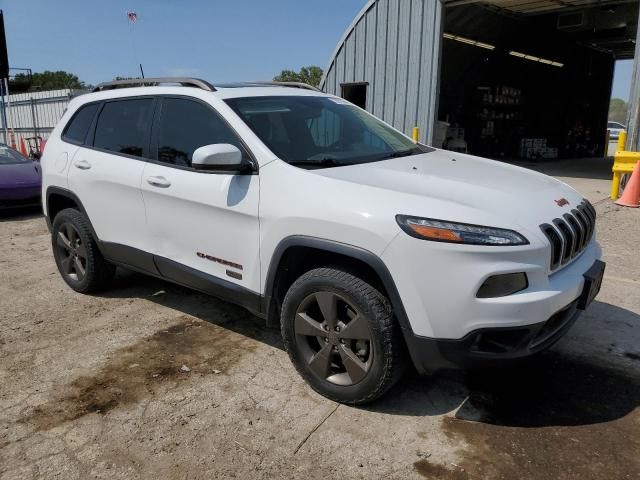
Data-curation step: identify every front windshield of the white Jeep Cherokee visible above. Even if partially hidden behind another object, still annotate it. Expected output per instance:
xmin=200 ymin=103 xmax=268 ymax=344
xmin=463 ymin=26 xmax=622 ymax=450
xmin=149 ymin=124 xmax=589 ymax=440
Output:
xmin=226 ymin=96 xmax=431 ymax=168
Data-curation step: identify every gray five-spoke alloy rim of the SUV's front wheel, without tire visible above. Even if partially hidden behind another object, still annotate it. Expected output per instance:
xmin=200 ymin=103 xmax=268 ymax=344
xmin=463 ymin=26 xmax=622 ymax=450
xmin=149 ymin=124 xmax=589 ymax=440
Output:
xmin=294 ymin=291 xmax=375 ymax=386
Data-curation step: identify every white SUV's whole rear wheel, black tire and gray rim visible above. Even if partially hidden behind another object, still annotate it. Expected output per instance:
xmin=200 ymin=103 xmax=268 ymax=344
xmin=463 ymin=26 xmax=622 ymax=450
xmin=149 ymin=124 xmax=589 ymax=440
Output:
xmin=51 ymin=208 xmax=116 ymax=293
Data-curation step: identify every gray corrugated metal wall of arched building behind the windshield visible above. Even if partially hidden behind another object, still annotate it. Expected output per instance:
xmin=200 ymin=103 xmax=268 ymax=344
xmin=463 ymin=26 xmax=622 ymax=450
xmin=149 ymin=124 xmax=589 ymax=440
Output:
xmin=320 ymin=0 xmax=442 ymax=143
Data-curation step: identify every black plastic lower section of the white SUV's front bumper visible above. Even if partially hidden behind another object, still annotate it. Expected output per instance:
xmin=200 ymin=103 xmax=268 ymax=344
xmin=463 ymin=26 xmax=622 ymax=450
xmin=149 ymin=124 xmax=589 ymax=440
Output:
xmin=407 ymin=301 xmax=581 ymax=373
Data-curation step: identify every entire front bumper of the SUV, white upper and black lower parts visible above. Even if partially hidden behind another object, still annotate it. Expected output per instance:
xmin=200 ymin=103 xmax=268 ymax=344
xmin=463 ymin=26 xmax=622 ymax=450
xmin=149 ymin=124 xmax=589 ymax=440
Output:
xmin=382 ymin=234 xmax=602 ymax=372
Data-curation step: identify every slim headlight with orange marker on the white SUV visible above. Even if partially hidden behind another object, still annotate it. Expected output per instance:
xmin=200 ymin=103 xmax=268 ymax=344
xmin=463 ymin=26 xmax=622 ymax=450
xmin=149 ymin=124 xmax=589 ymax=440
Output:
xmin=396 ymin=215 xmax=529 ymax=246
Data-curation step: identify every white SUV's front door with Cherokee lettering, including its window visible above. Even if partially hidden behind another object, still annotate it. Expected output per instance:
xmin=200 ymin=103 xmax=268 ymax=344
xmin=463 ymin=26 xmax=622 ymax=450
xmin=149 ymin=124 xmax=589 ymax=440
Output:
xmin=141 ymin=97 xmax=260 ymax=292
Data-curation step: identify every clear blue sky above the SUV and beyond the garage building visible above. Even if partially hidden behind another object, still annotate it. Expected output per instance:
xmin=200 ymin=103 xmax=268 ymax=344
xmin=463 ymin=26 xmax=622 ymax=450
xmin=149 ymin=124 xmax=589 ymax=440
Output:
xmin=0 ymin=0 xmax=632 ymax=100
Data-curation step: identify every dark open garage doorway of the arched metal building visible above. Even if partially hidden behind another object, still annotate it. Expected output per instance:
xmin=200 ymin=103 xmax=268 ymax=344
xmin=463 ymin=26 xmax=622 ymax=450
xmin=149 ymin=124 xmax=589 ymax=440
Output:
xmin=437 ymin=0 xmax=638 ymax=159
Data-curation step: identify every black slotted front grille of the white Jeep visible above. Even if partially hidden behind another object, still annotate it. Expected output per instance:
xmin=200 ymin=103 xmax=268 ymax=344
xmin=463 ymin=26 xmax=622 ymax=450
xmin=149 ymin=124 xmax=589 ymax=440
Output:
xmin=540 ymin=200 xmax=596 ymax=271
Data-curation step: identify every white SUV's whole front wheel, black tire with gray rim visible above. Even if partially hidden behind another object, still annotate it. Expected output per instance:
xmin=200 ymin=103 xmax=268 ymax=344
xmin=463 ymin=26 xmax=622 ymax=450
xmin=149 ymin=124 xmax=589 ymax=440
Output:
xmin=281 ymin=268 xmax=406 ymax=405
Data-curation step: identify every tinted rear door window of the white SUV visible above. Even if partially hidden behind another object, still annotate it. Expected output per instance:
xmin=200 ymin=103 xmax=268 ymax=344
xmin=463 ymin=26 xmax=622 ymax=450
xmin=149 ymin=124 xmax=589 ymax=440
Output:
xmin=93 ymin=98 xmax=153 ymax=157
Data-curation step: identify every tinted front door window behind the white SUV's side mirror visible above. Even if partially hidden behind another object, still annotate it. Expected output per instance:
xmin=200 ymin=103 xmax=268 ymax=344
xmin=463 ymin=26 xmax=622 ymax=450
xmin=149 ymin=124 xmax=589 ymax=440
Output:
xmin=158 ymin=98 xmax=248 ymax=167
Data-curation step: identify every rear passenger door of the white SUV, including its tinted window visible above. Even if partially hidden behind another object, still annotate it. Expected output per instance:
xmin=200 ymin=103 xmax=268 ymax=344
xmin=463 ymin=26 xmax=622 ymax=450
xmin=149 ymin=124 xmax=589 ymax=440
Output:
xmin=68 ymin=97 xmax=156 ymax=253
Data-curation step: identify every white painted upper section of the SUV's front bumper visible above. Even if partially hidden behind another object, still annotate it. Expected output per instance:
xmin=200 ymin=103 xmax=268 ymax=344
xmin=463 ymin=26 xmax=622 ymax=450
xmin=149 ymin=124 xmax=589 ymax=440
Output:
xmin=382 ymin=234 xmax=602 ymax=340
